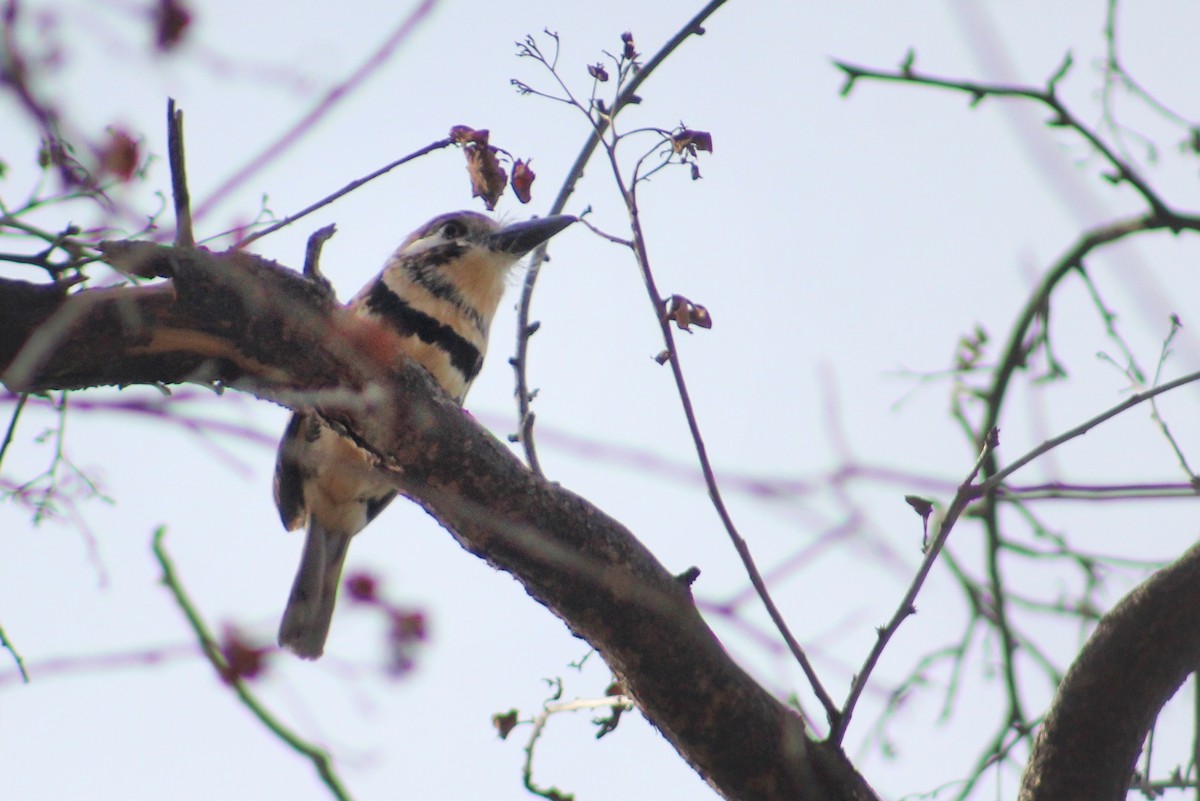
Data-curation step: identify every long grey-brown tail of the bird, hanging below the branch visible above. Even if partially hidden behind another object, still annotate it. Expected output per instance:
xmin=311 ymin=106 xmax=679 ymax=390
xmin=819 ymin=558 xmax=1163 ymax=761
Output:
xmin=280 ymin=517 xmax=350 ymax=660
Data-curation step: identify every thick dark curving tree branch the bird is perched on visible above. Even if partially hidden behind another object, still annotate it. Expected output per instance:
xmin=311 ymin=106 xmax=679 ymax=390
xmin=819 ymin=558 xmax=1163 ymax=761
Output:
xmin=0 ymin=242 xmax=875 ymax=801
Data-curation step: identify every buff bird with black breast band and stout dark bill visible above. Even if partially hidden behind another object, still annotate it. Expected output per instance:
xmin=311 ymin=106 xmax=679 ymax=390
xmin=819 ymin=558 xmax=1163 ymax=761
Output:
xmin=274 ymin=211 xmax=576 ymax=660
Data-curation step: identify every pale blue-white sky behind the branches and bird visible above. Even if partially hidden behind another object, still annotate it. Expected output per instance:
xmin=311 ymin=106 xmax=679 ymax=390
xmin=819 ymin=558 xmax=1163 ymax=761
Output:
xmin=0 ymin=0 xmax=1200 ymax=801
